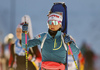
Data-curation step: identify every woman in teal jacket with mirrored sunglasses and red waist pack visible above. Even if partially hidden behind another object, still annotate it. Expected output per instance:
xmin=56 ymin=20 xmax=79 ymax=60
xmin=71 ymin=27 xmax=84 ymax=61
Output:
xmin=22 ymin=12 xmax=79 ymax=70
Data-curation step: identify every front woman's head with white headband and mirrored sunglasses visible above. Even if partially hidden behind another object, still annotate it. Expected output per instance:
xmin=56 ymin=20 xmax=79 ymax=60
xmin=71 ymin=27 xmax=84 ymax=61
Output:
xmin=48 ymin=12 xmax=62 ymax=31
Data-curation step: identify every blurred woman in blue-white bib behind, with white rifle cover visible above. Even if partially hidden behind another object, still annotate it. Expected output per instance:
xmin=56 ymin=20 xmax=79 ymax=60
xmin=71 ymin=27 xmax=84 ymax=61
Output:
xmin=9 ymin=15 xmax=42 ymax=70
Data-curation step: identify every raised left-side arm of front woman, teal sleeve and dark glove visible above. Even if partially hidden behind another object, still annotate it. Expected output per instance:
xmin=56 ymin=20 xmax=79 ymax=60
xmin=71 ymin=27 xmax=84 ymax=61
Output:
xmin=21 ymin=24 xmax=44 ymax=48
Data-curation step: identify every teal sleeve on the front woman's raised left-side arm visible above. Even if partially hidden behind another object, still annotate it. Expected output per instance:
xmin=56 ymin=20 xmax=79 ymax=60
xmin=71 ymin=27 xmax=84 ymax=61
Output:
xmin=22 ymin=33 xmax=44 ymax=48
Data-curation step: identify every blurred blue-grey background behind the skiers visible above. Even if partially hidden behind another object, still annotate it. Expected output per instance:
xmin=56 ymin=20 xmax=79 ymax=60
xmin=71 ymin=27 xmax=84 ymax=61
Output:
xmin=0 ymin=0 xmax=100 ymax=70
